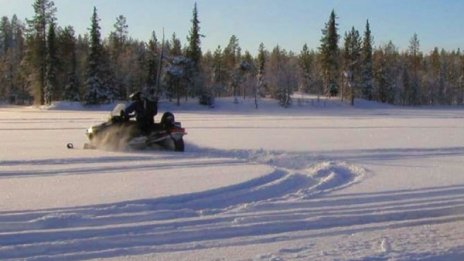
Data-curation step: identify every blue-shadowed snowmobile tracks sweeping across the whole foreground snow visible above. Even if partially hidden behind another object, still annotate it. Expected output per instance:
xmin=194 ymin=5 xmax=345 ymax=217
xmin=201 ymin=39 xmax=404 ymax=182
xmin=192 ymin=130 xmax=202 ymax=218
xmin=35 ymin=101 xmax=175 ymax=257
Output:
xmin=0 ymin=152 xmax=464 ymax=260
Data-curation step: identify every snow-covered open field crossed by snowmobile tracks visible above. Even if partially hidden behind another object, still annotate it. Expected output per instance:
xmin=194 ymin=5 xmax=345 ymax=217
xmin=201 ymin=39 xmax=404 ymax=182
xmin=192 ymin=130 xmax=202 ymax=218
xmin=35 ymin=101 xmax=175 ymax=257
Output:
xmin=0 ymin=96 xmax=464 ymax=260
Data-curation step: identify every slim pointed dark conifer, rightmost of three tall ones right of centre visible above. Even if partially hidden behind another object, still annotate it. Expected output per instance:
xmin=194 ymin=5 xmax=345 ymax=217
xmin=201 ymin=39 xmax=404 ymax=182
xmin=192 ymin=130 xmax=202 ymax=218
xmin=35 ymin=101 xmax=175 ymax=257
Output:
xmin=362 ymin=20 xmax=374 ymax=100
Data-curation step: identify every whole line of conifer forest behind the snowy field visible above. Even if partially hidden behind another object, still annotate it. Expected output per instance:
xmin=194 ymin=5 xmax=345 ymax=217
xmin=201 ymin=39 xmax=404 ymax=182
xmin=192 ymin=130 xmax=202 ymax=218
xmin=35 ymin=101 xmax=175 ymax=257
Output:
xmin=0 ymin=0 xmax=464 ymax=108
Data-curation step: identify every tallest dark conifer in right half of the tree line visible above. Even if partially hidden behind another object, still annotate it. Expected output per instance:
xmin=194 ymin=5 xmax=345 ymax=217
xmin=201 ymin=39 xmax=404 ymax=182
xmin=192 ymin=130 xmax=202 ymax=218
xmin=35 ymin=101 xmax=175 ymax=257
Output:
xmin=319 ymin=10 xmax=340 ymax=96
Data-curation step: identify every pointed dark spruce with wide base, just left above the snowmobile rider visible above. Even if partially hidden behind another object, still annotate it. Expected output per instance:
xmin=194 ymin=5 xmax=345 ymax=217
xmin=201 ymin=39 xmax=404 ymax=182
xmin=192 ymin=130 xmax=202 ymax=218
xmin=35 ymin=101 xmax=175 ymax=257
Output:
xmin=84 ymin=7 xmax=111 ymax=104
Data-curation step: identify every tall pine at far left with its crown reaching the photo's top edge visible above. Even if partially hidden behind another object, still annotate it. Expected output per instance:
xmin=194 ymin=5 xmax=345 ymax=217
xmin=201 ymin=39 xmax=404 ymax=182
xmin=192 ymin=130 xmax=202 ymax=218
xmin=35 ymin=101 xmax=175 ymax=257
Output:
xmin=27 ymin=0 xmax=56 ymax=105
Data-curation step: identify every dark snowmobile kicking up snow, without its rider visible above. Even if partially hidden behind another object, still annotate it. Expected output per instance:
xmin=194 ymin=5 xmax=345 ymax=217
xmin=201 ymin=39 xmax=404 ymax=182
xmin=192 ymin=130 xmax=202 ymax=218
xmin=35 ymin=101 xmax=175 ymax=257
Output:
xmin=84 ymin=104 xmax=187 ymax=151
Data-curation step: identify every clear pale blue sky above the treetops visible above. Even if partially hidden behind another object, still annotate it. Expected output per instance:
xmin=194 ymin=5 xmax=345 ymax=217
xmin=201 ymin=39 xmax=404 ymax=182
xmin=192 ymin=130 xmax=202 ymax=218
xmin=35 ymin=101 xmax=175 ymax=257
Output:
xmin=0 ymin=0 xmax=464 ymax=54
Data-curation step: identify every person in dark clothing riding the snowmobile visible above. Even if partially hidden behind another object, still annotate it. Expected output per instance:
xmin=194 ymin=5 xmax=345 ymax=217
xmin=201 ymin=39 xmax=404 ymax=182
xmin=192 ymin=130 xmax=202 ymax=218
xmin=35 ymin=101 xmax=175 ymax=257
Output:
xmin=124 ymin=90 xmax=158 ymax=134
